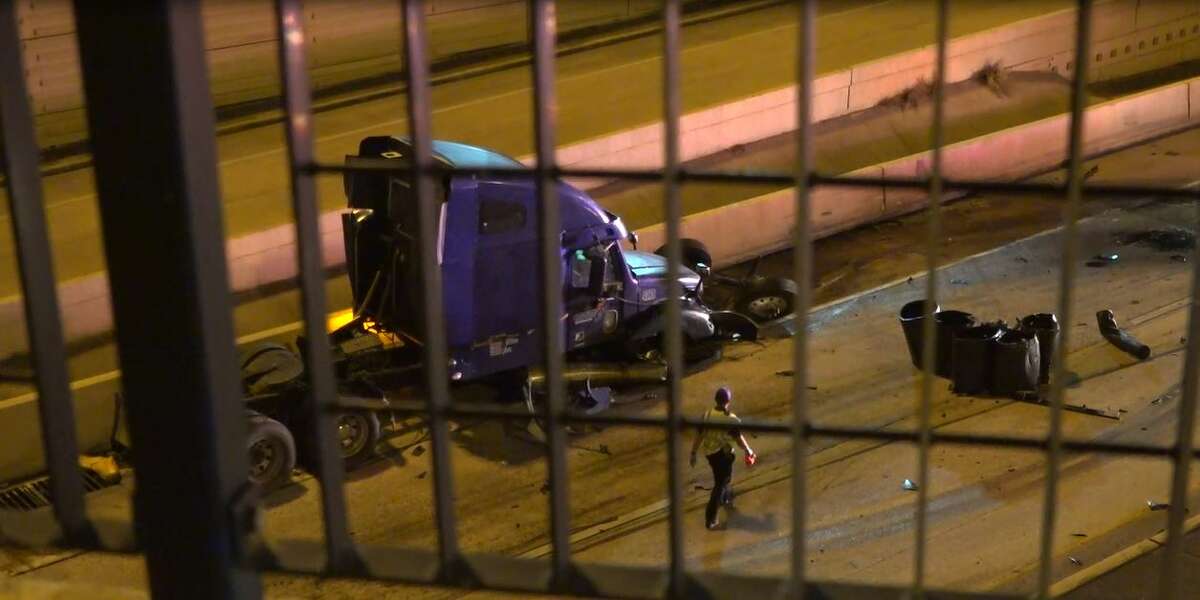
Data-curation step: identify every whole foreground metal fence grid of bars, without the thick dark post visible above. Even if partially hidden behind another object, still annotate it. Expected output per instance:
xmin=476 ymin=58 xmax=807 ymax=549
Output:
xmin=0 ymin=0 xmax=1200 ymax=598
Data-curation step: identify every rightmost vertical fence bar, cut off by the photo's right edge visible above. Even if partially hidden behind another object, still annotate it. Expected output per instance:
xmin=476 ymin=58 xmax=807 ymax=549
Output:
xmin=1158 ymin=204 xmax=1200 ymax=600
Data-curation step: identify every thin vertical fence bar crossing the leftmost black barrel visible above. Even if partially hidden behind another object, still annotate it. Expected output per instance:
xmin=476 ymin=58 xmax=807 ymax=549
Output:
xmin=912 ymin=0 xmax=949 ymax=598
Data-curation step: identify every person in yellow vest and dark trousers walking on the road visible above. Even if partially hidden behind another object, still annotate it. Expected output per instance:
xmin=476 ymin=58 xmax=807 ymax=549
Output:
xmin=689 ymin=386 xmax=756 ymax=529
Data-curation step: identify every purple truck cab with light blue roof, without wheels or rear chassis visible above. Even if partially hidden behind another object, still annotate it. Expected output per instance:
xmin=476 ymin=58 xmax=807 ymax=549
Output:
xmin=343 ymin=137 xmax=716 ymax=380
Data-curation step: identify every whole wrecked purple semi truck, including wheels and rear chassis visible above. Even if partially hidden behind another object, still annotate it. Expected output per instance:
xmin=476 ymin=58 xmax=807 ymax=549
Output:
xmin=242 ymin=137 xmax=794 ymax=486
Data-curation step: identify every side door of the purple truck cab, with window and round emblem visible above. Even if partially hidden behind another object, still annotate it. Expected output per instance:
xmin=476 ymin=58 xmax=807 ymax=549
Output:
xmin=563 ymin=242 xmax=625 ymax=349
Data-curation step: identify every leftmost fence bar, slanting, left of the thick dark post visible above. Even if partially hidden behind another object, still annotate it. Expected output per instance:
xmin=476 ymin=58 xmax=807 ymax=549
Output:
xmin=0 ymin=1 xmax=95 ymax=545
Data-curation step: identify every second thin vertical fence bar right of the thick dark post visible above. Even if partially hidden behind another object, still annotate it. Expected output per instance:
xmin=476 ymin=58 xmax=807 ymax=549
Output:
xmin=403 ymin=0 xmax=467 ymax=583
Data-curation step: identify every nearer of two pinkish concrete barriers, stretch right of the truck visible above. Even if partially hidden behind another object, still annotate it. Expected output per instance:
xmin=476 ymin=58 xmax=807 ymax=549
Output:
xmin=638 ymin=78 xmax=1200 ymax=266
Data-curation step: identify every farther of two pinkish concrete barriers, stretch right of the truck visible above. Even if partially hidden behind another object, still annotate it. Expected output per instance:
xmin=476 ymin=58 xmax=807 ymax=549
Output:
xmin=549 ymin=0 xmax=1200 ymax=174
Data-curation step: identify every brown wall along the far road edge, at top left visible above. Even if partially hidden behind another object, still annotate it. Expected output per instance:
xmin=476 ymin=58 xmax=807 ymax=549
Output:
xmin=17 ymin=0 xmax=660 ymax=146
